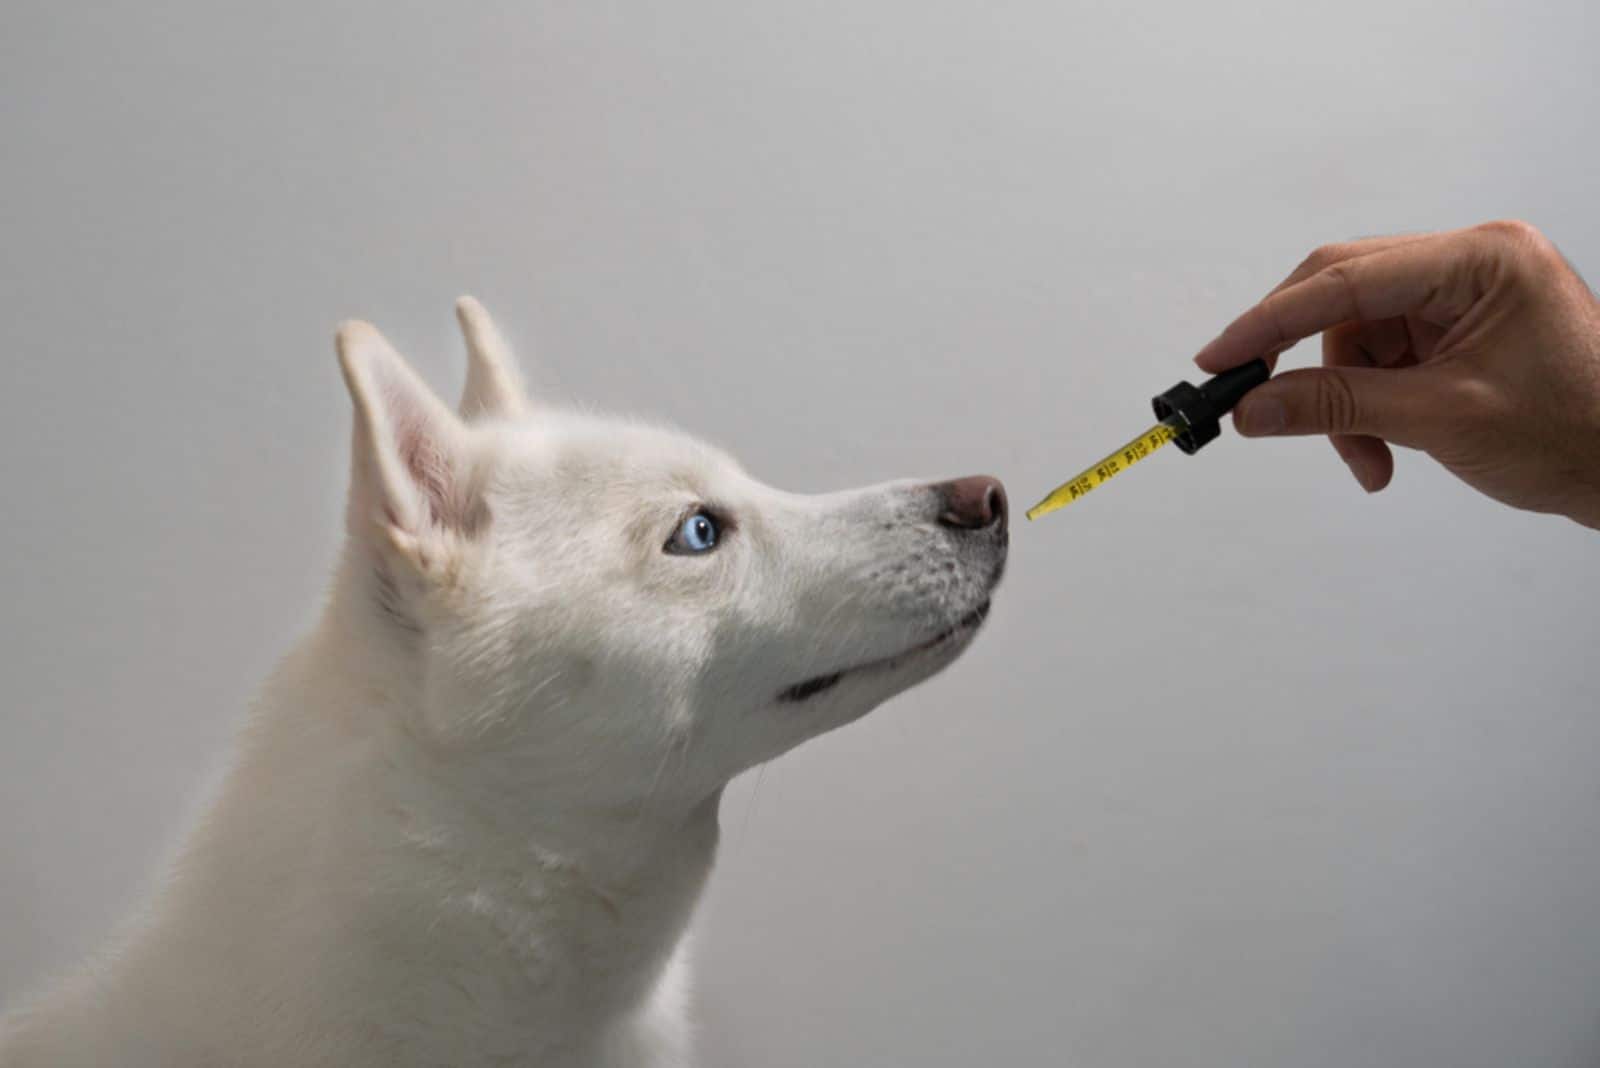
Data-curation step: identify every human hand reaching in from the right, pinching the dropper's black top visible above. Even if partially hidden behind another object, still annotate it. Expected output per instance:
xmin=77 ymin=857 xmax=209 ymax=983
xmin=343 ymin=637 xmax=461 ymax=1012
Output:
xmin=1195 ymin=222 xmax=1600 ymax=528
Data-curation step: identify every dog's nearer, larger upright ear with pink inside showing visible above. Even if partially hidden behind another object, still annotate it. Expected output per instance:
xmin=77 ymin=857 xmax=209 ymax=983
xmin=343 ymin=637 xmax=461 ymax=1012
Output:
xmin=338 ymin=323 xmax=483 ymax=572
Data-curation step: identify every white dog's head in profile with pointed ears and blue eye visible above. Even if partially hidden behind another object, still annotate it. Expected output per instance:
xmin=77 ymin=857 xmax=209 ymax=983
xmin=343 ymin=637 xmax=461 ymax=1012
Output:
xmin=338 ymin=299 xmax=1006 ymax=806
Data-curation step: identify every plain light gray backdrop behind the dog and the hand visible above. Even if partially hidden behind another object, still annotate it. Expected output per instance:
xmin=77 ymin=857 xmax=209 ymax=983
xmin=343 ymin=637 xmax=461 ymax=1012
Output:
xmin=0 ymin=0 xmax=1600 ymax=1068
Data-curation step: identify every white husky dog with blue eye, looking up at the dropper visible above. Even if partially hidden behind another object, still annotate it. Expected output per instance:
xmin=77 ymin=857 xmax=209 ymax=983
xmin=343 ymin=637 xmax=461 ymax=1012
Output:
xmin=0 ymin=297 xmax=1006 ymax=1068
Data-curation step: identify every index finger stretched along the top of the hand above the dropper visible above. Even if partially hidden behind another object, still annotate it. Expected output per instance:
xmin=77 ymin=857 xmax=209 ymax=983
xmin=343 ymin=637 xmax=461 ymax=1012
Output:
xmin=1195 ymin=230 xmax=1482 ymax=374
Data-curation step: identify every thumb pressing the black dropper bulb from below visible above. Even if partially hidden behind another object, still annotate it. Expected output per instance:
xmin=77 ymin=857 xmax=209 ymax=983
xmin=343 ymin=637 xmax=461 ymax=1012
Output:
xmin=1234 ymin=368 xmax=1438 ymax=448
